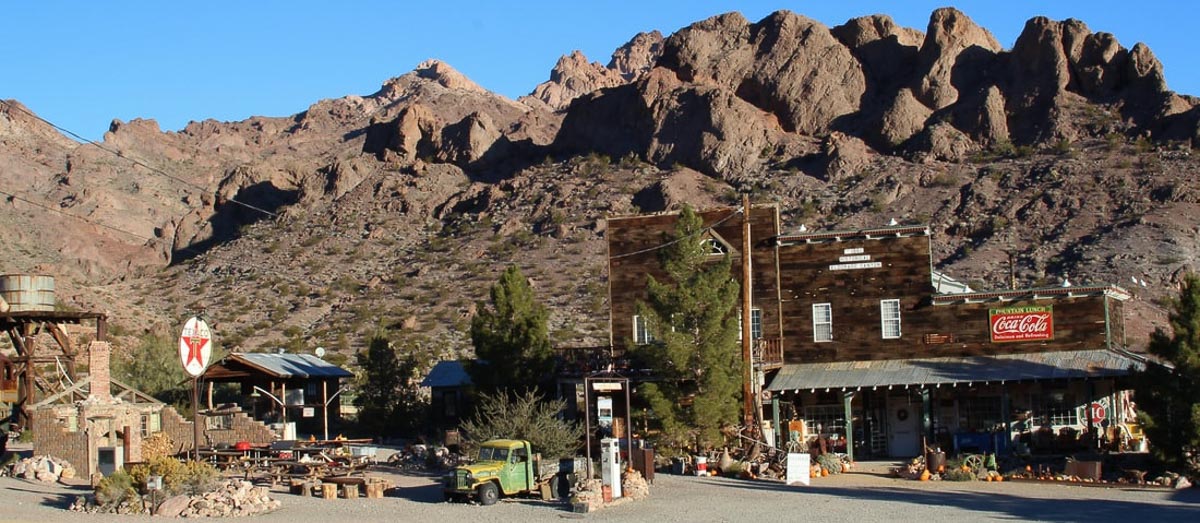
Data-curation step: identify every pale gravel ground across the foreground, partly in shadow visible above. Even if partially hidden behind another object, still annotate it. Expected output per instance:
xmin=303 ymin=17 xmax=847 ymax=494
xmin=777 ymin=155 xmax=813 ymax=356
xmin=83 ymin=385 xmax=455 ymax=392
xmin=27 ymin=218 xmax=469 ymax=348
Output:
xmin=0 ymin=465 xmax=1200 ymax=523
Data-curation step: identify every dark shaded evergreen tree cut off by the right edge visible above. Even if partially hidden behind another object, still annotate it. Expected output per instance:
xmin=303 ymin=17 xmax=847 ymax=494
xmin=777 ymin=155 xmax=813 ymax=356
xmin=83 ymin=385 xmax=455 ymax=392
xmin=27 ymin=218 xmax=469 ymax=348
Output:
xmin=1136 ymin=275 xmax=1200 ymax=471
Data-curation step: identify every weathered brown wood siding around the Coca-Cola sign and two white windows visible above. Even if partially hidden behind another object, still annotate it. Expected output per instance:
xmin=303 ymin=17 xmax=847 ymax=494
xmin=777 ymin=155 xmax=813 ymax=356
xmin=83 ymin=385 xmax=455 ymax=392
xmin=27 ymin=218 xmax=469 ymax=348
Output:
xmin=779 ymin=235 xmax=1123 ymax=362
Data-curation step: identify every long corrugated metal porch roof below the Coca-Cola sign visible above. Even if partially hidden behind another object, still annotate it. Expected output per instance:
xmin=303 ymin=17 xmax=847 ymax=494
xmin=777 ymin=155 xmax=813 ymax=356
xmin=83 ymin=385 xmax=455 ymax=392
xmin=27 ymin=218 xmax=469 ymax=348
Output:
xmin=767 ymin=349 xmax=1145 ymax=391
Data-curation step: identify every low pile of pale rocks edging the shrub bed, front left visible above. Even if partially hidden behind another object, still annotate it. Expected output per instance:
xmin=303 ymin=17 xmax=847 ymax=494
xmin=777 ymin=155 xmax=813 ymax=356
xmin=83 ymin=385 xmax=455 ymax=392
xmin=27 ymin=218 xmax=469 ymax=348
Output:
xmin=71 ymin=480 xmax=281 ymax=517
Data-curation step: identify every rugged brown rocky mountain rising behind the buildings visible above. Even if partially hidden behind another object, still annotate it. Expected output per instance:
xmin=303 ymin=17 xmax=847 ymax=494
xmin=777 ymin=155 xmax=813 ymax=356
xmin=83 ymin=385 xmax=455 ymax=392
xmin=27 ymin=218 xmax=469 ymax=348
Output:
xmin=0 ymin=8 xmax=1200 ymax=364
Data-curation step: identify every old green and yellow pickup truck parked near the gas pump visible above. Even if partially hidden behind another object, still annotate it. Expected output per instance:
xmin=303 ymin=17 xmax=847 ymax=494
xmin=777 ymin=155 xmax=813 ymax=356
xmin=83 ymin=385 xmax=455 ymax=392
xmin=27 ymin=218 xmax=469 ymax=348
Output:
xmin=442 ymin=439 xmax=558 ymax=505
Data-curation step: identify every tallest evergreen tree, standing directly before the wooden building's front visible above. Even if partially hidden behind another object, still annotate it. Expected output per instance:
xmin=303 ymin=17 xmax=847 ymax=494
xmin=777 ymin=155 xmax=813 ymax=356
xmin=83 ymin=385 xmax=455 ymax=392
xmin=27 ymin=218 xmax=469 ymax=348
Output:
xmin=630 ymin=206 xmax=743 ymax=447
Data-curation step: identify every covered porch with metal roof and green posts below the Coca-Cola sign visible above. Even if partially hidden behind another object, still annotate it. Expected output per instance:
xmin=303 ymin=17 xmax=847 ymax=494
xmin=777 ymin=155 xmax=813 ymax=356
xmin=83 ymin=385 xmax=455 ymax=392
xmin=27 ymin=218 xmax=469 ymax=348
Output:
xmin=764 ymin=349 xmax=1145 ymax=458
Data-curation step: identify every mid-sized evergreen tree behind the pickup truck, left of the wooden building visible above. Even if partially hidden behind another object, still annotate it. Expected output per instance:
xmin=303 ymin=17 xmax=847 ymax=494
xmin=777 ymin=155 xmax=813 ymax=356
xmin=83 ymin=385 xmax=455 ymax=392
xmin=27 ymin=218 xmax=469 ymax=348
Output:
xmin=468 ymin=266 xmax=554 ymax=392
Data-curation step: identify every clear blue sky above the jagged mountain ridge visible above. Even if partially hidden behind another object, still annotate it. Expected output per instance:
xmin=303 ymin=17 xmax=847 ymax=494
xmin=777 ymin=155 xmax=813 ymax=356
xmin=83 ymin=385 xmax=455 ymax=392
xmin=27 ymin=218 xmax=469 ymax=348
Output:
xmin=7 ymin=0 xmax=1200 ymax=139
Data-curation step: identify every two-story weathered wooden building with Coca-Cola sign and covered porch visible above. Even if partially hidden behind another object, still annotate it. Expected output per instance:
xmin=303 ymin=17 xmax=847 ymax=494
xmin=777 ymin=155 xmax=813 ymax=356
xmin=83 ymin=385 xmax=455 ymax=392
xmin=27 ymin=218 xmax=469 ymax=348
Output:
xmin=608 ymin=205 xmax=1144 ymax=456
